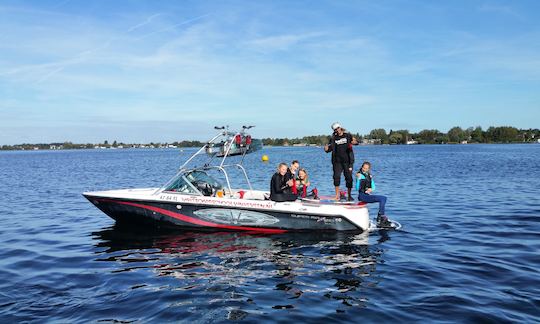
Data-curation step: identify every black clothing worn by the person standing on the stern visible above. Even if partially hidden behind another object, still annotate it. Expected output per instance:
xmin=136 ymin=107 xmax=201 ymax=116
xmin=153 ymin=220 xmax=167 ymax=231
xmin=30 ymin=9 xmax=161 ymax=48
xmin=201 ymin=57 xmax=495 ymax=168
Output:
xmin=327 ymin=133 xmax=354 ymax=188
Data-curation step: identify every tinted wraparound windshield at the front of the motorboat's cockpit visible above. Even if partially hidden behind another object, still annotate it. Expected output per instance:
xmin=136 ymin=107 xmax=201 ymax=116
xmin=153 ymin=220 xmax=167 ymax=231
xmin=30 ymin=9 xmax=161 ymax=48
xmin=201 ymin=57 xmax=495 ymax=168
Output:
xmin=165 ymin=170 xmax=223 ymax=196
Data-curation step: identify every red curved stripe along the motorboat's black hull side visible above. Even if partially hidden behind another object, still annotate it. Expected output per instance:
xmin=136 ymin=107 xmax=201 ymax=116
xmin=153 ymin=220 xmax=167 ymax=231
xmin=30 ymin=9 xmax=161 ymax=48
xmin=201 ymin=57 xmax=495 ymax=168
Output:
xmin=97 ymin=199 xmax=287 ymax=233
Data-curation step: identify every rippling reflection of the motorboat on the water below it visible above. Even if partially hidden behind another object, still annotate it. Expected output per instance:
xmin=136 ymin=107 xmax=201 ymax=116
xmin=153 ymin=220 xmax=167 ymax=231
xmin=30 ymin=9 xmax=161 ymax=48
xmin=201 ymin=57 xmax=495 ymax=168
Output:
xmin=90 ymin=224 xmax=390 ymax=319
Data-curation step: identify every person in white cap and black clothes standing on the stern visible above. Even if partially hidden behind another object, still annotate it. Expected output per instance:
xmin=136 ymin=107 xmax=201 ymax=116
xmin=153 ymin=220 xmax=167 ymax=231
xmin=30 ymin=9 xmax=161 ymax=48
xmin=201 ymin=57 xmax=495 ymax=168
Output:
xmin=324 ymin=122 xmax=358 ymax=201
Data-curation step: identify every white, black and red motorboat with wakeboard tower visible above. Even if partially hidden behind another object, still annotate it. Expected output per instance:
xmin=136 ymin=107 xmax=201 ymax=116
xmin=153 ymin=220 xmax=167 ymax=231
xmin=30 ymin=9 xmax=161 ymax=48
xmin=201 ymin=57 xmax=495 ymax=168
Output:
xmin=83 ymin=126 xmax=370 ymax=233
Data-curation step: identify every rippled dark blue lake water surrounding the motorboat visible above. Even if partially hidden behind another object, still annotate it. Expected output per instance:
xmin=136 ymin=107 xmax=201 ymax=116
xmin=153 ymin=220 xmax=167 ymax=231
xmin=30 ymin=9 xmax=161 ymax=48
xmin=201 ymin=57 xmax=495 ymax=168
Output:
xmin=0 ymin=145 xmax=540 ymax=323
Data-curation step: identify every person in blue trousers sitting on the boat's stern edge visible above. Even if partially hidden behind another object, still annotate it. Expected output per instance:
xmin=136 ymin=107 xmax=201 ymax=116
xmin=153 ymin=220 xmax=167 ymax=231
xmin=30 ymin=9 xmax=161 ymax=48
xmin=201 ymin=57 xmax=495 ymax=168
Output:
xmin=356 ymin=161 xmax=392 ymax=227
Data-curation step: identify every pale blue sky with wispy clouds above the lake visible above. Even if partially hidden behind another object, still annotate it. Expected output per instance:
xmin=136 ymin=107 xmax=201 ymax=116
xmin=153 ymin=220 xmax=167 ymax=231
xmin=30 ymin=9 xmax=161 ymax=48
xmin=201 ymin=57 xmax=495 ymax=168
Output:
xmin=0 ymin=0 xmax=540 ymax=144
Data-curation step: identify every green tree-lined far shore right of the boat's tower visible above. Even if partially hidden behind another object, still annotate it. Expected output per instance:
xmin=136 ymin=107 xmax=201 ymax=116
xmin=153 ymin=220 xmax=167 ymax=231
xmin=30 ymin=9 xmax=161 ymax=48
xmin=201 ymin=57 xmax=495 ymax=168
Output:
xmin=263 ymin=126 xmax=540 ymax=146
